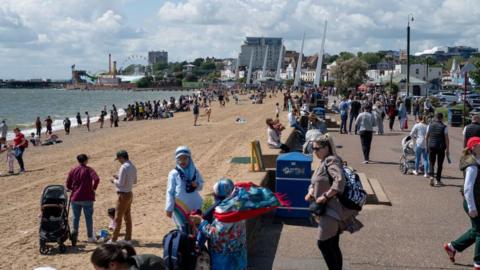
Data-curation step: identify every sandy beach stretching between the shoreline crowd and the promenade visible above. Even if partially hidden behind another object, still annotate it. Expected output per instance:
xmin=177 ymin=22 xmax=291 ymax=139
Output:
xmin=0 ymin=95 xmax=280 ymax=269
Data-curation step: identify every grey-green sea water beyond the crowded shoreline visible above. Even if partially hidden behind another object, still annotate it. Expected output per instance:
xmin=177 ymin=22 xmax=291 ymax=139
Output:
xmin=0 ymin=88 xmax=191 ymax=140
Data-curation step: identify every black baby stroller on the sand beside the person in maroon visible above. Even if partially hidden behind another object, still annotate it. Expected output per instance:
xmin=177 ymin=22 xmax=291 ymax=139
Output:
xmin=39 ymin=185 xmax=76 ymax=255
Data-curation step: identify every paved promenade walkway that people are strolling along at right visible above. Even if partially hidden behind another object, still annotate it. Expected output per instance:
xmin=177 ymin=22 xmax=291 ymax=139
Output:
xmin=251 ymin=116 xmax=473 ymax=269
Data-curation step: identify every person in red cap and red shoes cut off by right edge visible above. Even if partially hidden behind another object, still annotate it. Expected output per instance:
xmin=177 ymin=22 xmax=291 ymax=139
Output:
xmin=443 ymin=136 xmax=480 ymax=270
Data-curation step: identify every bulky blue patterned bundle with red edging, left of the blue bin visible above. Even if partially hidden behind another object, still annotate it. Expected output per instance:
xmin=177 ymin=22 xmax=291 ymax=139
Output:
xmin=213 ymin=182 xmax=290 ymax=223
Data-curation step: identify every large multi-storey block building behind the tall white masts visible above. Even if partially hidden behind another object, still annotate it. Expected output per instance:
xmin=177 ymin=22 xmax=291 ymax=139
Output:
xmin=239 ymin=37 xmax=285 ymax=70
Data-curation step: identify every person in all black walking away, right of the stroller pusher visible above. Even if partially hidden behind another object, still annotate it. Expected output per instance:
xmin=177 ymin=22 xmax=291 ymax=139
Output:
xmin=427 ymin=113 xmax=450 ymax=187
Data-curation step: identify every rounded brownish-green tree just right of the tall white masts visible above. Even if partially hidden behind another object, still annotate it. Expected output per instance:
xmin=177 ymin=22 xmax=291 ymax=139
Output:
xmin=332 ymin=57 xmax=368 ymax=94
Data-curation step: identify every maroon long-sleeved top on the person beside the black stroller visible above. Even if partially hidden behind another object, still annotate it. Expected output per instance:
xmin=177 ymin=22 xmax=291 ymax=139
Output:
xmin=66 ymin=165 xmax=100 ymax=201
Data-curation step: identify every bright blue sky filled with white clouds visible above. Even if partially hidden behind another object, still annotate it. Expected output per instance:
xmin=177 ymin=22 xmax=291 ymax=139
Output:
xmin=0 ymin=0 xmax=480 ymax=79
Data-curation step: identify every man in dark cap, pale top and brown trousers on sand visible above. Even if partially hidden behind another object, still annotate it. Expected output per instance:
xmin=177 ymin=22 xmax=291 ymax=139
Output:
xmin=110 ymin=150 xmax=137 ymax=242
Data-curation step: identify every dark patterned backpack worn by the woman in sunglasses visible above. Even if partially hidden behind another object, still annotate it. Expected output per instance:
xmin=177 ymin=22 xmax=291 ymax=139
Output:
xmin=325 ymin=164 xmax=367 ymax=211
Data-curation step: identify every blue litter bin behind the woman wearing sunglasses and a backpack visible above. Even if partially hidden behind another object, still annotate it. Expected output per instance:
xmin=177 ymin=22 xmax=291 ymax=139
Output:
xmin=275 ymin=152 xmax=312 ymax=218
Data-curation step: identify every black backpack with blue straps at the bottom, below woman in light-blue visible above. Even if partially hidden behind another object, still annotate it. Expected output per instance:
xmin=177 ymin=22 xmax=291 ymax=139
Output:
xmin=163 ymin=230 xmax=197 ymax=270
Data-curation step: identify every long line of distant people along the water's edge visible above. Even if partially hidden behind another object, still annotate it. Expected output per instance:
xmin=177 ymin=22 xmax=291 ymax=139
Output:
xmin=0 ymin=89 xmax=238 ymax=175
